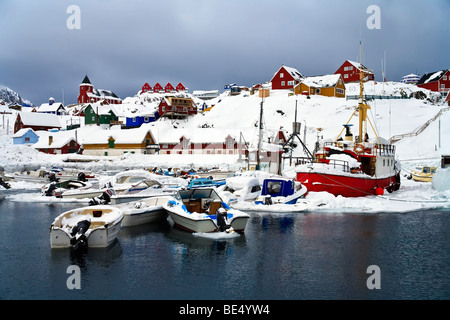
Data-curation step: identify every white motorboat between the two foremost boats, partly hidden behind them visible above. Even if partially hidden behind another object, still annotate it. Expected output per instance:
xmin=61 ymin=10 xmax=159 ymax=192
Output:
xmin=116 ymin=196 xmax=172 ymax=227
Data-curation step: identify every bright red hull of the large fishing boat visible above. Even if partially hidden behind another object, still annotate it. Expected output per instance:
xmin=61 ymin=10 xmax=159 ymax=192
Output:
xmin=297 ymin=171 xmax=400 ymax=197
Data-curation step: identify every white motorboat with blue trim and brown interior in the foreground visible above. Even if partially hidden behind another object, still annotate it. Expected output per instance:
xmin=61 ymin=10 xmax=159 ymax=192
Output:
xmin=164 ymin=188 xmax=249 ymax=232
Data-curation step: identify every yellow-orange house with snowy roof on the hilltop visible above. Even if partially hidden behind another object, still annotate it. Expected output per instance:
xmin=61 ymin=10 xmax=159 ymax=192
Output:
xmin=294 ymin=74 xmax=345 ymax=98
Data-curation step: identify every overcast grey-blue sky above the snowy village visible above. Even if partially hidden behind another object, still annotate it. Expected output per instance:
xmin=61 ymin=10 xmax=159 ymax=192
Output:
xmin=0 ymin=0 xmax=450 ymax=105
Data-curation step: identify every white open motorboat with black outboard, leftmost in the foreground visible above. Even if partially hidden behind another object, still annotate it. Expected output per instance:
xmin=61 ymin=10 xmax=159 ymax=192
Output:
xmin=50 ymin=205 xmax=124 ymax=248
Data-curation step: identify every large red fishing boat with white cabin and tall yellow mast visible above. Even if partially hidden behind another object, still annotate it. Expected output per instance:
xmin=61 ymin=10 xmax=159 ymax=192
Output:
xmin=295 ymin=47 xmax=400 ymax=197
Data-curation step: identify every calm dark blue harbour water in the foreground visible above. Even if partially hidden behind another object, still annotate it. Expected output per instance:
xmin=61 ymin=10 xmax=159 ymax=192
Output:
xmin=0 ymin=194 xmax=450 ymax=300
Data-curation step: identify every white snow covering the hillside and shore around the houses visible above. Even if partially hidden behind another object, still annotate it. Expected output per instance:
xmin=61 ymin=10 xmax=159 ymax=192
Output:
xmin=0 ymin=83 xmax=450 ymax=212
